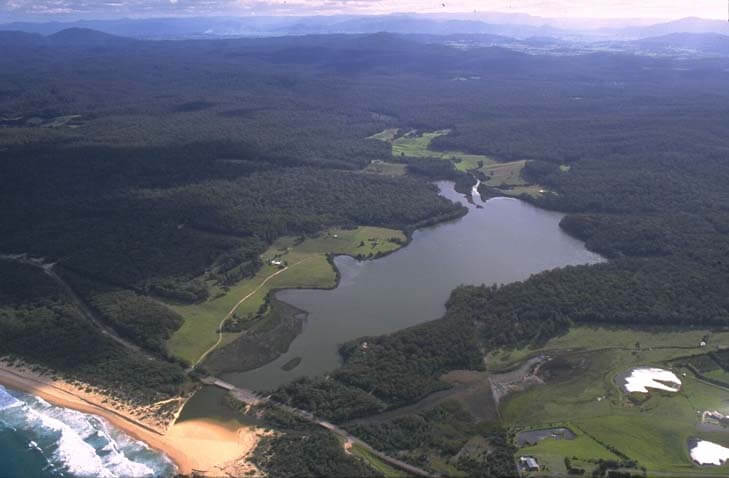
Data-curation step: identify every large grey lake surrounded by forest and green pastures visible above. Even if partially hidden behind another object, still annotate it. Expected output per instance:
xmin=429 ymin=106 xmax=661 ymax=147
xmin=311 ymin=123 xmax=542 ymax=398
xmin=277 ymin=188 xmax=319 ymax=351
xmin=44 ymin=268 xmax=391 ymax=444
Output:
xmin=228 ymin=182 xmax=602 ymax=390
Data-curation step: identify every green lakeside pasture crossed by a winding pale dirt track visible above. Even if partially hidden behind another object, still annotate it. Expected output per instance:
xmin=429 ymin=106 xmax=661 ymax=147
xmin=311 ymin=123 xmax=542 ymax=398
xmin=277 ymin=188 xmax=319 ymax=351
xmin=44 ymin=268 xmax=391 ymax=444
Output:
xmin=167 ymin=227 xmax=406 ymax=363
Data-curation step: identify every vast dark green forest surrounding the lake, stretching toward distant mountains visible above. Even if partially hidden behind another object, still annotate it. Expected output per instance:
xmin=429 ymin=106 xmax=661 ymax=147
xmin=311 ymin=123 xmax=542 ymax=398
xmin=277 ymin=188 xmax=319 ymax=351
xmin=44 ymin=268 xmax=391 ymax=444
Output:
xmin=0 ymin=31 xmax=729 ymax=476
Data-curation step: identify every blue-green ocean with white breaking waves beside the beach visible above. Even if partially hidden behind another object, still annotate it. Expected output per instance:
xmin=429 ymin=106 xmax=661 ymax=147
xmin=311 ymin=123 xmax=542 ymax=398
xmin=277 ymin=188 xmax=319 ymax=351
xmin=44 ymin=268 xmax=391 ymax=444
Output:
xmin=0 ymin=386 xmax=176 ymax=478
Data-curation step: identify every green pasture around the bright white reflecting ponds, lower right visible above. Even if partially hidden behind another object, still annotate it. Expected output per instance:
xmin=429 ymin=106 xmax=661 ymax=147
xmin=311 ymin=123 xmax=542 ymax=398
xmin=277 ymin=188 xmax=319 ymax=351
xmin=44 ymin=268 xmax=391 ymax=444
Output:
xmin=500 ymin=327 xmax=729 ymax=474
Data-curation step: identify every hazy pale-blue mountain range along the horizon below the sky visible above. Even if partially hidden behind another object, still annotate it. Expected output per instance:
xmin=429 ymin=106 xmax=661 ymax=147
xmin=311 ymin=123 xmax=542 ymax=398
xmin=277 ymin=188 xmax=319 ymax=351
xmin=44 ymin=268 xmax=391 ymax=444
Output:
xmin=0 ymin=13 xmax=729 ymax=40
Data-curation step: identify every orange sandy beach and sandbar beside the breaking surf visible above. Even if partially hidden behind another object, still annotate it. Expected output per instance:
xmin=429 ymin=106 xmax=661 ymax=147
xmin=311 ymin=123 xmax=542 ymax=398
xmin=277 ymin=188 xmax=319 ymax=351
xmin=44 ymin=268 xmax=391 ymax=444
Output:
xmin=0 ymin=363 xmax=264 ymax=476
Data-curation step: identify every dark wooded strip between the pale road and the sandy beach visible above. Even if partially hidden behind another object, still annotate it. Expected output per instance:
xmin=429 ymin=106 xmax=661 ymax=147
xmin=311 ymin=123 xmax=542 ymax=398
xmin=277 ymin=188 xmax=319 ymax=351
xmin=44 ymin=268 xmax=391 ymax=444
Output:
xmin=0 ymin=260 xmax=185 ymax=405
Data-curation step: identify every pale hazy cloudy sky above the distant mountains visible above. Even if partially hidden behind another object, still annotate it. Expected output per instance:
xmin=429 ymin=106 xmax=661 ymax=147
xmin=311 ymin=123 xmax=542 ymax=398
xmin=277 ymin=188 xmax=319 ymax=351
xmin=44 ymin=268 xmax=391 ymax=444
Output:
xmin=0 ymin=0 xmax=728 ymax=22
